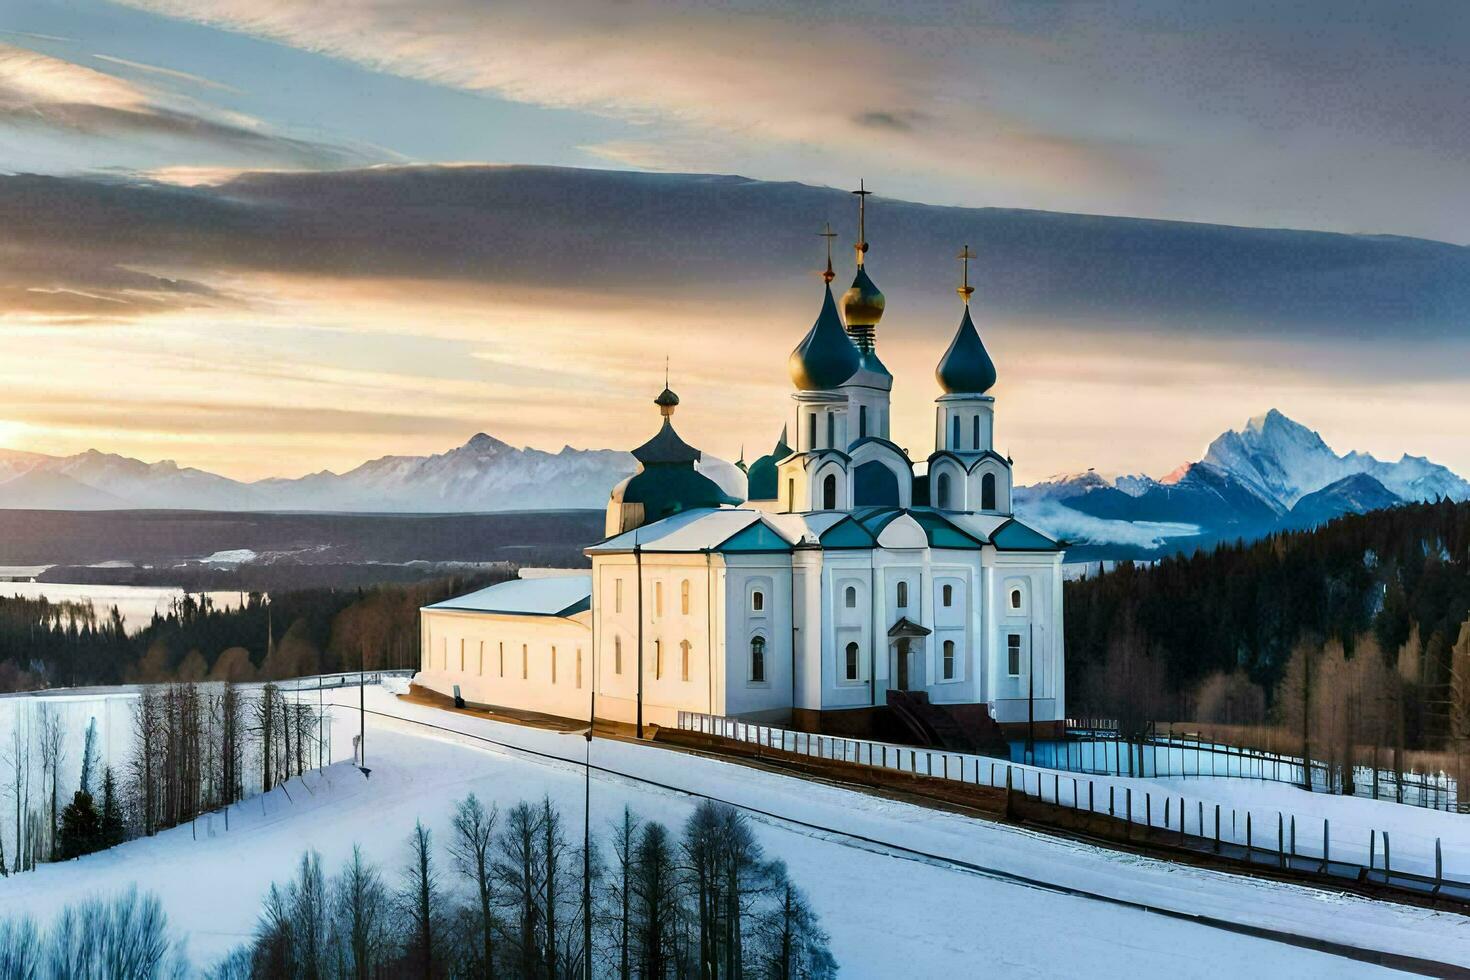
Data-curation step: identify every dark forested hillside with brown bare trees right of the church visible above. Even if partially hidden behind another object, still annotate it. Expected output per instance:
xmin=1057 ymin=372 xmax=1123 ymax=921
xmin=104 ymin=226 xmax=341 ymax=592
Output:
xmin=1064 ymin=501 xmax=1470 ymax=792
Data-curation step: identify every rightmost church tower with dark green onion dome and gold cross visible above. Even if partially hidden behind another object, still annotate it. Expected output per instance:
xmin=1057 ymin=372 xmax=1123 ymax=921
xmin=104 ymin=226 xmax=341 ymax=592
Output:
xmin=929 ymin=245 xmax=1011 ymax=514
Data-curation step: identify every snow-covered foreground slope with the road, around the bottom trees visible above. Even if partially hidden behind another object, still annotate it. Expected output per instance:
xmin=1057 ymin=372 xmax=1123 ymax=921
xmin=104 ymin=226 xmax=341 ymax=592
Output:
xmin=0 ymin=689 xmax=1470 ymax=979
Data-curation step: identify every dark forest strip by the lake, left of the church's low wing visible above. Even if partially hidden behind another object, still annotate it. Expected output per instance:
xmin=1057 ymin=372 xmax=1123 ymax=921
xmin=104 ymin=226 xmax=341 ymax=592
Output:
xmin=0 ymin=572 xmax=510 ymax=693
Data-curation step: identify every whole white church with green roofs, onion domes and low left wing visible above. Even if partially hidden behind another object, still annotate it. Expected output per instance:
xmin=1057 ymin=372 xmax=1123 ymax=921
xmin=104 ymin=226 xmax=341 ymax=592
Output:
xmin=416 ymin=192 xmax=1064 ymax=743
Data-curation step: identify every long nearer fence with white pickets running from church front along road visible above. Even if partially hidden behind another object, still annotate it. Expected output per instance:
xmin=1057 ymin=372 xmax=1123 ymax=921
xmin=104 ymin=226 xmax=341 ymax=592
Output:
xmin=678 ymin=711 xmax=1470 ymax=902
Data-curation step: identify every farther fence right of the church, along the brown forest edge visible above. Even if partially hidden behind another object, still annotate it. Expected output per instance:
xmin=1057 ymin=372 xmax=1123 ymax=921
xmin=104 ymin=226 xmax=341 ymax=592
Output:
xmin=1058 ymin=718 xmax=1461 ymax=811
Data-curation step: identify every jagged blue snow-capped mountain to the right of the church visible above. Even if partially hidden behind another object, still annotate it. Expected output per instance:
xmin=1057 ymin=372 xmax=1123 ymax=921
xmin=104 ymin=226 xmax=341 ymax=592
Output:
xmin=1016 ymin=408 xmax=1470 ymax=551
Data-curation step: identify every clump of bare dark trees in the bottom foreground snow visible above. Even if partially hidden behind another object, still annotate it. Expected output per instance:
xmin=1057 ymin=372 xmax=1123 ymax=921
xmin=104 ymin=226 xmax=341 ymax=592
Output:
xmin=215 ymin=795 xmax=838 ymax=980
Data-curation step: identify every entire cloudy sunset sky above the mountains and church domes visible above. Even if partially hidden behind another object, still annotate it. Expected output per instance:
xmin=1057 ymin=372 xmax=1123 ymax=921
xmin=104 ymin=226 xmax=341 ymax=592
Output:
xmin=0 ymin=0 xmax=1470 ymax=480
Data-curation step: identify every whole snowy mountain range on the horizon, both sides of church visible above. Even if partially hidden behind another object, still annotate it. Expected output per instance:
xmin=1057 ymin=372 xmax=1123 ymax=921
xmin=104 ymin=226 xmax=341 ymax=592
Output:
xmin=0 ymin=408 xmax=1470 ymax=558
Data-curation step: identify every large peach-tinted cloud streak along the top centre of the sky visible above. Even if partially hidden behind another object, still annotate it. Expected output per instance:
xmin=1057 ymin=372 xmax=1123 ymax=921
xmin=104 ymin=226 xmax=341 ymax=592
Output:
xmin=123 ymin=0 xmax=1139 ymax=196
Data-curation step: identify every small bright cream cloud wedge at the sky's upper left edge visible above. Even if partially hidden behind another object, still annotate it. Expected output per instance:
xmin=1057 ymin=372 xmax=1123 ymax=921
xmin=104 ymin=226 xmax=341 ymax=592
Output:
xmin=0 ymin=44 xmax=365 ymax=167
